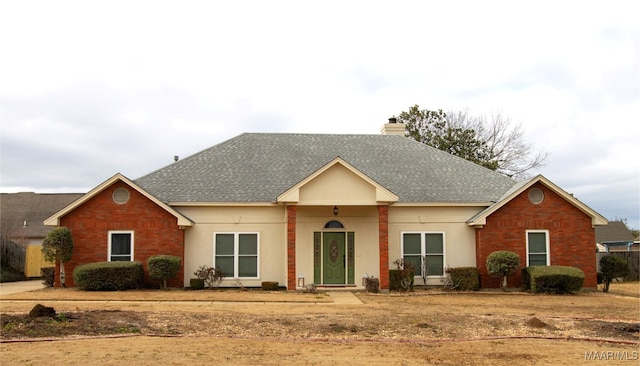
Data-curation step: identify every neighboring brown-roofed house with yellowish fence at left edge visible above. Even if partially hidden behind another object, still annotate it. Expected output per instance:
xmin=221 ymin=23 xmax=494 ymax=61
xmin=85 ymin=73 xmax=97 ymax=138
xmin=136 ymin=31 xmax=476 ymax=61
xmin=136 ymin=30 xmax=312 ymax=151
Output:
xmin=0 ymin=192 xmax=83 ymax=277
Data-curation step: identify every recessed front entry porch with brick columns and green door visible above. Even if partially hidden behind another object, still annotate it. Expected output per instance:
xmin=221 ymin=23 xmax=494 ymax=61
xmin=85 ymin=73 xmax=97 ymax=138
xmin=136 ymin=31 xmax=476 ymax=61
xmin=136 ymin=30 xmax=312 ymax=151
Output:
xmin=287 ymin=205 xmax=389 ymax=290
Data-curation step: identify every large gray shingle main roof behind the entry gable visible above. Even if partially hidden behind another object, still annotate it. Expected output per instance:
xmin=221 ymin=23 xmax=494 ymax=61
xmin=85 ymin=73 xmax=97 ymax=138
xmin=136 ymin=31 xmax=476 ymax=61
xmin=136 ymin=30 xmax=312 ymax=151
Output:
xmin=135 ymin=133 xmax=516 ymax=203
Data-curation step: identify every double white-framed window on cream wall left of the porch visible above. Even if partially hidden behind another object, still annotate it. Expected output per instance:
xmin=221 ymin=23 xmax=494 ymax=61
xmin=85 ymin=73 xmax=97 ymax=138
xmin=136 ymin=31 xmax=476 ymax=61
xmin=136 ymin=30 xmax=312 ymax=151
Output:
xmin=213 ymin=233 xmax=260 ymax=278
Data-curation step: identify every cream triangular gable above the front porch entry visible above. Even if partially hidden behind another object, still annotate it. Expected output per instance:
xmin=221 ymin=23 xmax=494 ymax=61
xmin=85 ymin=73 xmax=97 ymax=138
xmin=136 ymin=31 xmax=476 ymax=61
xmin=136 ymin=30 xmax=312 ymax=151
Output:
xmin=277 ymin=157 xmax=398 ymax=206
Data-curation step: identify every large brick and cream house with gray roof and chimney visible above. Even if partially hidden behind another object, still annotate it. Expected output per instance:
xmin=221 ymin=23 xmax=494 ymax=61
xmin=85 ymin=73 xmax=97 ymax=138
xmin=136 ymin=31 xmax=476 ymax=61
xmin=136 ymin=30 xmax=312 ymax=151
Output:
xmin=45 ymin=123 xmax=607 ymax=290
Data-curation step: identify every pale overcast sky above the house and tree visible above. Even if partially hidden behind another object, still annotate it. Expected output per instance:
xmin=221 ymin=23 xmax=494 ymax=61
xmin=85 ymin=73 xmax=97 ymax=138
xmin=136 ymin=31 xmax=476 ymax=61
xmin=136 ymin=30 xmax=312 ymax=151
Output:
xmin=0 ymin=0 xmax=640 ymax=228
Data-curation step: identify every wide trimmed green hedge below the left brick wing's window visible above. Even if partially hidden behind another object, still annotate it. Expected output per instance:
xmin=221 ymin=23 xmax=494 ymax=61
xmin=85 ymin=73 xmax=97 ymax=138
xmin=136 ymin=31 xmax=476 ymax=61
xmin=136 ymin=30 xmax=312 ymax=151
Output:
xmin=73 ymin=262 xmax=144 ymax=291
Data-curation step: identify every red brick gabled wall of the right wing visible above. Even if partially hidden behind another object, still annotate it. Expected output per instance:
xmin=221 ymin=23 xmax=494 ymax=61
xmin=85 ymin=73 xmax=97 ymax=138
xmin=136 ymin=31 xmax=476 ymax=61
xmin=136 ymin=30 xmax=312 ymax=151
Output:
xmin=476 ymin=183 xmax=596 ymax=288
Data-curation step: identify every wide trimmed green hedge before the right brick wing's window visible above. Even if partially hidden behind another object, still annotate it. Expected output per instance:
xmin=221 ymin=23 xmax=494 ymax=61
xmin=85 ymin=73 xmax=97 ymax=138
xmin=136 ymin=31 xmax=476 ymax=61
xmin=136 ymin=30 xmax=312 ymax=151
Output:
xmin=522 ymin=266 xmax=584 ymax=294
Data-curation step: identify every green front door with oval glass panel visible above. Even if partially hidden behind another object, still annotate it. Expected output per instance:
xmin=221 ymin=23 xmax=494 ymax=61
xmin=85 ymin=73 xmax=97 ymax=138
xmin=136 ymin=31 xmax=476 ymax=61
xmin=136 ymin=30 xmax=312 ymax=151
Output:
xmin=322 ymin=232 xmax=347 ymax=285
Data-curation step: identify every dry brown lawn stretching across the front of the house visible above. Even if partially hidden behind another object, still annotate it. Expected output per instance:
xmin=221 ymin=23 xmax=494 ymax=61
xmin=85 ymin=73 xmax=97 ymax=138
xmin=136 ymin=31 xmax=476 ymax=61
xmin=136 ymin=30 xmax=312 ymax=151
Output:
xmin=0 ymin=282 xmax=640 ymax=365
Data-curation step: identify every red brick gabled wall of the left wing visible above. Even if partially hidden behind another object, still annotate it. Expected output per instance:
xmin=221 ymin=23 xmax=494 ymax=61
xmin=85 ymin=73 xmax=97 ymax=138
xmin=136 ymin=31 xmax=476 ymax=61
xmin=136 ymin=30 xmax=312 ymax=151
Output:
xmin=56 ymin=181 xmax=184 ymax=287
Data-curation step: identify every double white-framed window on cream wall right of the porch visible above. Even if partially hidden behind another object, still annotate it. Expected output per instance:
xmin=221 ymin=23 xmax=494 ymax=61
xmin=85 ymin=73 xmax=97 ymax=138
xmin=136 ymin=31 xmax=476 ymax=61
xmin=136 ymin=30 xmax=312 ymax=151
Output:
xmin=402 ymin=231 xmax=445 ymax=277
